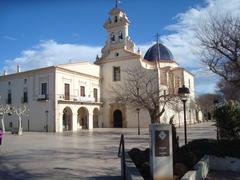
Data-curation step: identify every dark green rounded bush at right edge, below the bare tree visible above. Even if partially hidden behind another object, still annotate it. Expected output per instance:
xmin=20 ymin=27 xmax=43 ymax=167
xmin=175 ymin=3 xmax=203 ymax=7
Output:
xmin=214 ymin=101 xmax=240 ymax=139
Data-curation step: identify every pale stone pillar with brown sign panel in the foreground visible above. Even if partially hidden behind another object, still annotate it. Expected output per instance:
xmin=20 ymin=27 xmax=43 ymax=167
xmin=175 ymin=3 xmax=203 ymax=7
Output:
xmin=149 ymin=124 xmax=173 ymax=180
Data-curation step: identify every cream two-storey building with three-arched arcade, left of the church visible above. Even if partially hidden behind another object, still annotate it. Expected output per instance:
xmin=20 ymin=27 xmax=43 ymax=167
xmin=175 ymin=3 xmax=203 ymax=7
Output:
xmin=0 ymin=62 xmax=101 ymax=132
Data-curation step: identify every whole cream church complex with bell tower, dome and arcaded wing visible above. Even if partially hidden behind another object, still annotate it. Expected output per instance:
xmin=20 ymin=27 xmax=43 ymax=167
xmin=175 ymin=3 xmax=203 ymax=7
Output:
xmin=0 ymin=5 xmax=201 ymax=132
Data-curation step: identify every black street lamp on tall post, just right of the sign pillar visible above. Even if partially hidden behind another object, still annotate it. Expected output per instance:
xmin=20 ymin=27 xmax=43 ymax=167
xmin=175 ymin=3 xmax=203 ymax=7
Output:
xmin=178 ymin=85 xmax=190 ymax=145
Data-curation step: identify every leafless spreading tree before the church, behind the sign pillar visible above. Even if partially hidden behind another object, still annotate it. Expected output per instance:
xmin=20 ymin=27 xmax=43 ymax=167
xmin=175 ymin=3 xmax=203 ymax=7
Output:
xmin=112 ymin=67 xmax=177 ymax=123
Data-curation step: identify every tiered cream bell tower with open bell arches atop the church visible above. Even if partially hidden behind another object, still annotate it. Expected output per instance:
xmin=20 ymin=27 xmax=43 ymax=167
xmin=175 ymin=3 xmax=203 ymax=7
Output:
xmin=99 ymin=3 xmax=135 ymax=58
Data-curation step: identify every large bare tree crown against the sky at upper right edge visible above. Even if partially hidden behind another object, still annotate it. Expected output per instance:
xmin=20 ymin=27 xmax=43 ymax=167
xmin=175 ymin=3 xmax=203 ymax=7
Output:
xmin=196 ymin=15 xmax=240 ymax=87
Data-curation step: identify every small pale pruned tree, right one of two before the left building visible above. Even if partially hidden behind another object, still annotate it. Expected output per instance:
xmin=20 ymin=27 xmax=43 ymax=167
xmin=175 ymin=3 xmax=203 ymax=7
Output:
xmin=13 ymin=105 xmax=29 ymax=135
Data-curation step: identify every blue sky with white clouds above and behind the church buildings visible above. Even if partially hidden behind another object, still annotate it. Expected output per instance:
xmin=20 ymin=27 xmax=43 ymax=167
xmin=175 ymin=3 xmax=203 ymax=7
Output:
xmin=0 ymin=0 xmax=240 ymax=93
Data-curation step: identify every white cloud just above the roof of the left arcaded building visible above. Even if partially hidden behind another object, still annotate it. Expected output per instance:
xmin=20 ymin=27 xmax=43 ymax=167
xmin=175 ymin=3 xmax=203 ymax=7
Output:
xmin=4 ymin=40 xmax=101 ymax=73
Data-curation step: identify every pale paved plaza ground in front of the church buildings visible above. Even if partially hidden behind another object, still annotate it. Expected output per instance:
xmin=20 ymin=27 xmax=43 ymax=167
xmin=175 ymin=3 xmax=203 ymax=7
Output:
xmin=0 ymin=122 xmax=216 ymax=180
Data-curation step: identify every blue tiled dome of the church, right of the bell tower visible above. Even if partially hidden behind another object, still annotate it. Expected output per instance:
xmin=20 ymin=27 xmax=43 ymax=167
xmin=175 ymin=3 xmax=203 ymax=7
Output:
xmin=144 ymin=43 xmax=174 ymax=62
